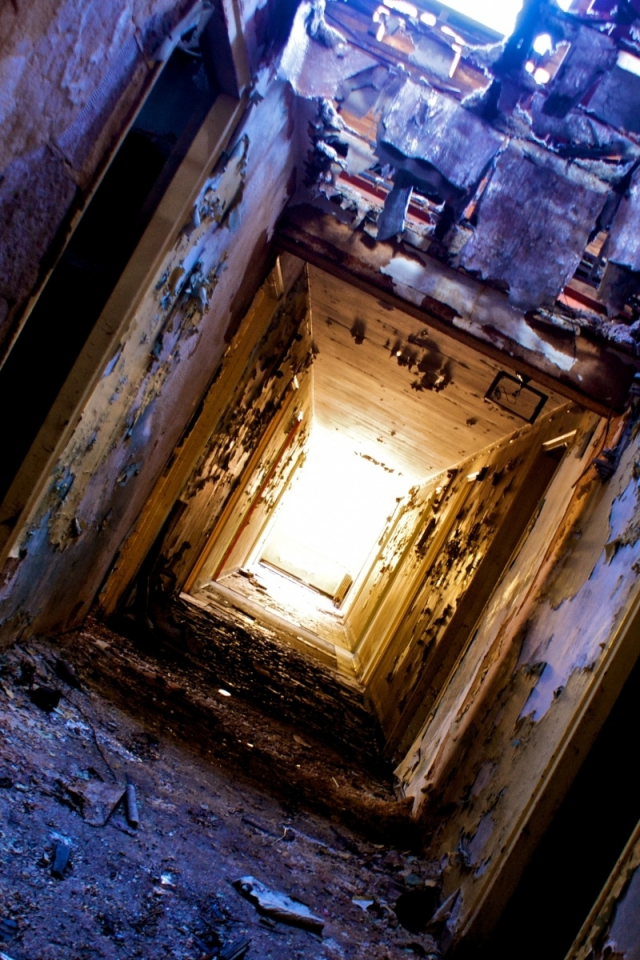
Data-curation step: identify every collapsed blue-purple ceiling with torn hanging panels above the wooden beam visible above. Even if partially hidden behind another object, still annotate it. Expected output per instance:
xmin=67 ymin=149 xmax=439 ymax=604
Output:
xmin=280 ymin=0 xmax=640 ymax=398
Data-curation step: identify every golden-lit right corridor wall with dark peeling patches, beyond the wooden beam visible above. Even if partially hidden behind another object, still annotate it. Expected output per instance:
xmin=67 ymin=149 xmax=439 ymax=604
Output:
xmin=358 ymin=408 xmax=584 ymax=756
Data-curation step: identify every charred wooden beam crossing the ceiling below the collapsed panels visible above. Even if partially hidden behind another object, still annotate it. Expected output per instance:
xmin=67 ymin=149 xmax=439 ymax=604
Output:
xmin=277 ymin=205 xmax=640 ymax=416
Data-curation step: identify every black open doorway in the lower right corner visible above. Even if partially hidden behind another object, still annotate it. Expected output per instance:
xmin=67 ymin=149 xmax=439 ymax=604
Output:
xmin=465 ymin=640 xmax=640 ymax=960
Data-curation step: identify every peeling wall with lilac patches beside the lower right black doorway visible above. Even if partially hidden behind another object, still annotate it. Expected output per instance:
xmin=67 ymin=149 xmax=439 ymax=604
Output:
xmin=397 ymin=408 xmax=640 ymax=938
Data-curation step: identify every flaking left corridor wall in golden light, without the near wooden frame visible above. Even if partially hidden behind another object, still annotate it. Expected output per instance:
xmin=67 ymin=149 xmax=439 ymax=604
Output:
xmin=156 ymin=264 xmax=313 ymax=585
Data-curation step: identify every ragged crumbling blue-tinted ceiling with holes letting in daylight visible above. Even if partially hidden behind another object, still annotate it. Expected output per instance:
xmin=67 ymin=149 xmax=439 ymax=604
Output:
xmin=280 ymin=2 xmax=640 ymax=412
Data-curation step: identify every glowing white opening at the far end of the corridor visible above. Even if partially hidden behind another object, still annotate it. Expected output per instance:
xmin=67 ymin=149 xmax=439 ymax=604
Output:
xmin=208 ymin=419 xmax=416 ymax=656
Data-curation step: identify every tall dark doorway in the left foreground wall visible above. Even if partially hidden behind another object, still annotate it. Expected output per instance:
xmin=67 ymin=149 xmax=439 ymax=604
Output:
xmin=0 ymin=48 xmax=217 ymax=497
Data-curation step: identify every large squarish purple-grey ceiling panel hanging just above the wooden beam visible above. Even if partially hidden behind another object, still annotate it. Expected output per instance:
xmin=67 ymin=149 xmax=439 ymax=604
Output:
xmin=460 ymin=143 xmax=606 ymax=310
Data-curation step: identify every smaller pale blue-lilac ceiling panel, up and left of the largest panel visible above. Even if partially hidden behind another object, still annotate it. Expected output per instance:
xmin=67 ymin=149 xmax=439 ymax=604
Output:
xmin=378 ymin=80 xmax=503 ymax=191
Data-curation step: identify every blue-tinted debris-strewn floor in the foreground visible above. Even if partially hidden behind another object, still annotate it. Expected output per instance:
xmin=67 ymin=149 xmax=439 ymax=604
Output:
xmin=0 ymin=625 xmax=438 ymax=960
